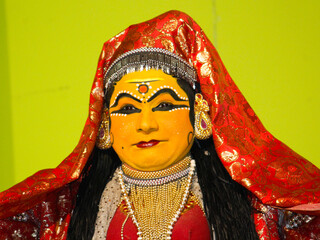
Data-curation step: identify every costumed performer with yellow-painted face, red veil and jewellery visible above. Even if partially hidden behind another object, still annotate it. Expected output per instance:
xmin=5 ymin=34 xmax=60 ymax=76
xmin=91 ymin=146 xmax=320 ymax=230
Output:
xmin=0 ymin=11 xmax=320 ymax=240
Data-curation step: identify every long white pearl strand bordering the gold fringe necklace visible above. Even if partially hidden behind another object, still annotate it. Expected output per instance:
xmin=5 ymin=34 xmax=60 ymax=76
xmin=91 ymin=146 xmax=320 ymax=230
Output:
xmin=118 ymin=159 xmax=196 ymax=240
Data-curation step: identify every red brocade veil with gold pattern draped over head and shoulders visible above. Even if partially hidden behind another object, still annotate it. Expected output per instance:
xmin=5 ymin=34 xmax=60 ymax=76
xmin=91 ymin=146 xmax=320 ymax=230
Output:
xmin=0 ymin=11 xmax=320 ymax=239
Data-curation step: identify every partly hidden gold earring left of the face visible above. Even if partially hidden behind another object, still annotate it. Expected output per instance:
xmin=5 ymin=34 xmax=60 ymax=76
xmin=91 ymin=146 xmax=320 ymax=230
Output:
xmin=96 ymin=109 xmax=112 ymax=149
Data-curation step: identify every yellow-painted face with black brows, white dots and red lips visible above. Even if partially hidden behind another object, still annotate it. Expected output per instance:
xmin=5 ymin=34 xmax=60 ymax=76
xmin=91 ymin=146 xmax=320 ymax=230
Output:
xmin=110 ymin=70 xmax=193 ymax=171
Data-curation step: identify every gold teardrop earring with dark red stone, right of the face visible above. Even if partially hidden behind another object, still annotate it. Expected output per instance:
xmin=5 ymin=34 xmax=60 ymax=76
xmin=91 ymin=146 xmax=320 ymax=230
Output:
xmin=194 ymin=93 xmax=212 ymax=140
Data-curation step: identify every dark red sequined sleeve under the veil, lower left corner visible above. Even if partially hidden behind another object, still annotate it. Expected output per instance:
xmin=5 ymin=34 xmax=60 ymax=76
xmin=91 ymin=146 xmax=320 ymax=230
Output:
xmin=0 ymin=185 xmax=74 ymax=240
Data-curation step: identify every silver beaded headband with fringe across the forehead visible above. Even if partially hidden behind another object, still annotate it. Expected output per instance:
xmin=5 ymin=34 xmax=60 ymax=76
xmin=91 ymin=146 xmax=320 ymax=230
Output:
xmin=104 ymin=48 xmax=197 ymax=92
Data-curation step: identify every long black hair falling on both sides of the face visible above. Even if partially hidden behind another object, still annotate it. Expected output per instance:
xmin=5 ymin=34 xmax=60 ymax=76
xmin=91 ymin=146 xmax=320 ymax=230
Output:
xmin=67 ymin=75 xmax=259 ymax=240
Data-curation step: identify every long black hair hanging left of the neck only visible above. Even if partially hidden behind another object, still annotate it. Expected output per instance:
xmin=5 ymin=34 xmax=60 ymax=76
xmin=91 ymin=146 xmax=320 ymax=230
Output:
xmin=67 ymin=147 xmax=121 ymax=240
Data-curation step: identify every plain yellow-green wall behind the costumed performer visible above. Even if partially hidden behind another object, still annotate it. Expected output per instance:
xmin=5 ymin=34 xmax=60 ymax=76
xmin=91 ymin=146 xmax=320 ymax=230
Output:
xmin=0 ymin=0 xmax=320 ymax=190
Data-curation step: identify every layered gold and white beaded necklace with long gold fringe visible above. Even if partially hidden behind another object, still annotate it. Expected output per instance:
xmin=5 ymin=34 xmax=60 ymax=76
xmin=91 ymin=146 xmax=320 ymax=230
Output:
xmin=118 ymin=157 xmax=195 ymax=240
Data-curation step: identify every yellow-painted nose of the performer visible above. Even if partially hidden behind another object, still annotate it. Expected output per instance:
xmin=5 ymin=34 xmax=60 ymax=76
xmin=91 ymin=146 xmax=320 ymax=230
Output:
xmin=137 ymin=109 xmax=159 ymax=134
